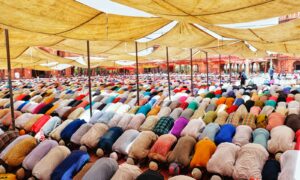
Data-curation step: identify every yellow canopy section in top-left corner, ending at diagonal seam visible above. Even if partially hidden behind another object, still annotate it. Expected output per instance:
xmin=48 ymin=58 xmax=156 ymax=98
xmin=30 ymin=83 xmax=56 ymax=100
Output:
xmin=0 ymin=0 xmax=101 ymax=34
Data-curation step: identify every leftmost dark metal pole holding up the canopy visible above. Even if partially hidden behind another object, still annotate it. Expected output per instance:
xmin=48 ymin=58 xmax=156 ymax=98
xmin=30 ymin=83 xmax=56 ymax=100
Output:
xmin=5 ymin=29 xmax=15 ymax=129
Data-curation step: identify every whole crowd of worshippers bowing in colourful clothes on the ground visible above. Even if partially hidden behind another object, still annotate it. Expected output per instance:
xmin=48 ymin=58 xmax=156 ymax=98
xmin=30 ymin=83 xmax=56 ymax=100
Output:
xmin=0 ymin=77 xmax=300 ymax=180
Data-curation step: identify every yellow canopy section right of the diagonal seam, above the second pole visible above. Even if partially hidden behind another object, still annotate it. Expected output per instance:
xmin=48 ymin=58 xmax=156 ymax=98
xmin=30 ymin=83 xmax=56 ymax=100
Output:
xmin=59 ymin=14 xmax=170 ymax=41
